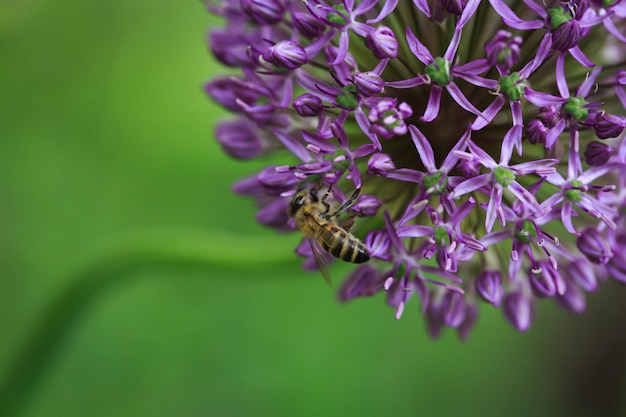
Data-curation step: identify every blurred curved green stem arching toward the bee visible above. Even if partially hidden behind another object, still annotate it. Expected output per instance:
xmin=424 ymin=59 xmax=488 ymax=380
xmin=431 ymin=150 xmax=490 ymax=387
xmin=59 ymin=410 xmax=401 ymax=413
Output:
xmin=0 ymin=231 xmax=297 ymax=417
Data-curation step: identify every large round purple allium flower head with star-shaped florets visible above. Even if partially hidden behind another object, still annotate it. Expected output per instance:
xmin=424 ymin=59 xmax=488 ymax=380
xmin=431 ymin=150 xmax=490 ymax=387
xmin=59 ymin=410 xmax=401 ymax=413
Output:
xmin=206 ymin=0 xmax=626 ymax=339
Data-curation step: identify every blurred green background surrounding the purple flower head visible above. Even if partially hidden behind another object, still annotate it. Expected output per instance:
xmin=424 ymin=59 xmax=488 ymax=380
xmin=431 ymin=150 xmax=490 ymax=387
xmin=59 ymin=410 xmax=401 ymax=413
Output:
xmin=0 ymin=0 xmax=626 ymax=417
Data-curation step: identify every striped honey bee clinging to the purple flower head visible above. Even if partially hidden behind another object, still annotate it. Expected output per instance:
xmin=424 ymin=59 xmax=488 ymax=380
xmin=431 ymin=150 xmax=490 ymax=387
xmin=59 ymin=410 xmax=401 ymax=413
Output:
xmin=289 ymin=186 xmax=370 ymax=285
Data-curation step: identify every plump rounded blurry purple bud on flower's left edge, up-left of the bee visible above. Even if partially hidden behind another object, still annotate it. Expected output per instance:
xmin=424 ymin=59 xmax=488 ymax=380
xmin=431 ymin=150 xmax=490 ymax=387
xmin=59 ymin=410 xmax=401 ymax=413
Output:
xmin=215 ymin=120 xmax=263 ymax=159
